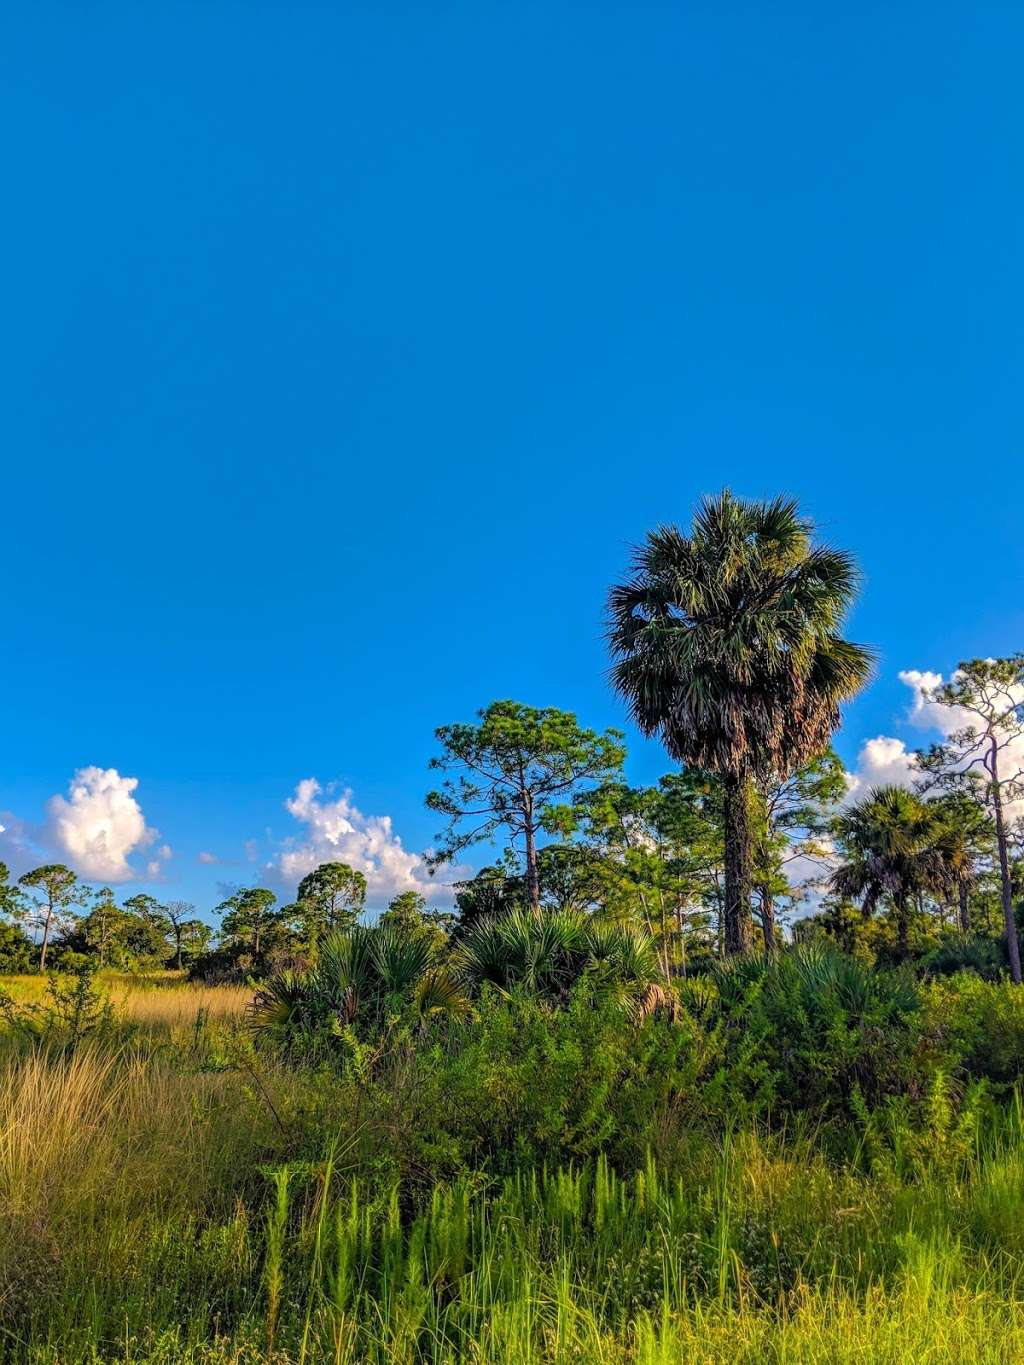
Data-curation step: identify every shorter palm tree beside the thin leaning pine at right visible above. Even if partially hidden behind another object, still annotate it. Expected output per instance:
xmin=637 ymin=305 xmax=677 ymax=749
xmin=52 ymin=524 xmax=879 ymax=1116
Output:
xmin=831 ymin=786 xmax=958 ymax=957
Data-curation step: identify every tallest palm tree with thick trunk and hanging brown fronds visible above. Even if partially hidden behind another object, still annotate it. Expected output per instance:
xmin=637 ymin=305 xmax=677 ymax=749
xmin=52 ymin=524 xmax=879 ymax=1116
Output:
xmin=609 ymin=490 xmax=871 ymax=954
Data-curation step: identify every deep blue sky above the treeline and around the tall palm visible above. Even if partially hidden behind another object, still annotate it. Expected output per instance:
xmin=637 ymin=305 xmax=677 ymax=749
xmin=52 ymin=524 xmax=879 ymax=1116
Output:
xmin=0 ymin=0 xmax=1024 ymax=909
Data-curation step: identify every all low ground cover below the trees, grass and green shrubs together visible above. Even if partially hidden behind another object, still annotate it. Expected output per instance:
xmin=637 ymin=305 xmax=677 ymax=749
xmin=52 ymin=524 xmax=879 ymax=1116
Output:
xmin=0 ymin=960 xmax=1024 ymax=1362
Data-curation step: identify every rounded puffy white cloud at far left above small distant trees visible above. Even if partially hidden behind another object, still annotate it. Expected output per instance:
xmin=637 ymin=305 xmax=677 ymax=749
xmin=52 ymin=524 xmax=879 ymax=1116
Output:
xmin=46 ymin=767 xmax=158 ymax=882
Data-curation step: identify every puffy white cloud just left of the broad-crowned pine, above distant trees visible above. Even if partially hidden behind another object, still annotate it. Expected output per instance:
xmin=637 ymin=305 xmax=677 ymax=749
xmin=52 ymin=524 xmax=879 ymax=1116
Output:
xmin=266 ymin=778 xmax=451 ymax=908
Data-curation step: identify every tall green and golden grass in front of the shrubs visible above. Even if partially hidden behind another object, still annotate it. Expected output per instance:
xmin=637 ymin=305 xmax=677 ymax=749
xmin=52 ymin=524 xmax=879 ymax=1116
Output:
xmin=0 ymin=973 xmax=1024 ymax=1365
